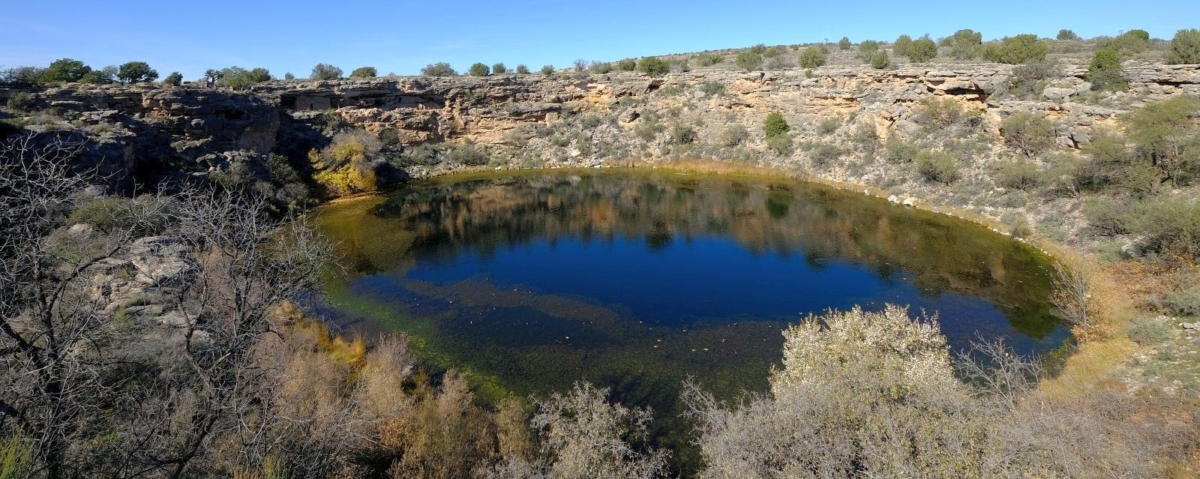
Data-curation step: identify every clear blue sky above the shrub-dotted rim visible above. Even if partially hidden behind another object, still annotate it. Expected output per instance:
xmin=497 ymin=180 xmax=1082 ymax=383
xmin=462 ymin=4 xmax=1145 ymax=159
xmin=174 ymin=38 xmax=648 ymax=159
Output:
xmin=0 ymin=0 xmax=1200 ymax=79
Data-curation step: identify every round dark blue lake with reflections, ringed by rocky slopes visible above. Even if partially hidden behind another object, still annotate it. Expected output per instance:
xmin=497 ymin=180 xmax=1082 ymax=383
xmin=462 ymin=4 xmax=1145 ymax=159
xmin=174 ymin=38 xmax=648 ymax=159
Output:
xmin=314 ymin=172 xmax=1069 ymax=408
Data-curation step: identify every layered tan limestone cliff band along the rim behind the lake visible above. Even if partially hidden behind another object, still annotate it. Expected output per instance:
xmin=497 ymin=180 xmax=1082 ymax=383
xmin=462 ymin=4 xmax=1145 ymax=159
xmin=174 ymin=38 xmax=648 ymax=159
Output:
xmin=0 ymin=64 xmax=1200 ymax=187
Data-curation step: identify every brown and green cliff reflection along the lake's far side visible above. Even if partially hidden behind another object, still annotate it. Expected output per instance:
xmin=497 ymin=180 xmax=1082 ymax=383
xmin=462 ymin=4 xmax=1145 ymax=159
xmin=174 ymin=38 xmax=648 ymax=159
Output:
xmin=360 ymin=174 xmax=1055 ymax=337
